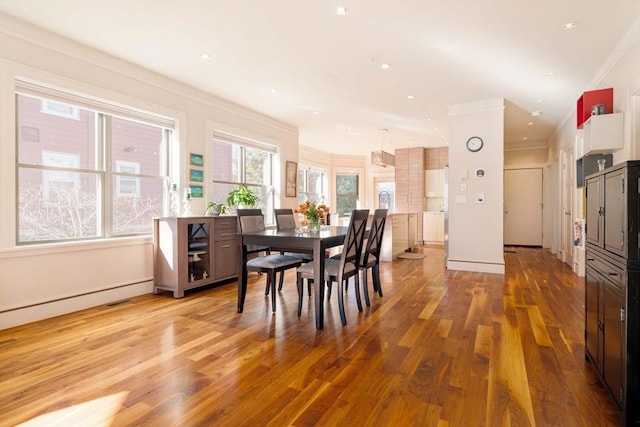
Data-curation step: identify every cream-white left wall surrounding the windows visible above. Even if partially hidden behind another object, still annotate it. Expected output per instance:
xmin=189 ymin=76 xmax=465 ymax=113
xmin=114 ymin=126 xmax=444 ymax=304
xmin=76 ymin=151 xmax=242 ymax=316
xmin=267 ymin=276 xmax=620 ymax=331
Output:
xmin=0 ymin=15 xmax=298 ymax=329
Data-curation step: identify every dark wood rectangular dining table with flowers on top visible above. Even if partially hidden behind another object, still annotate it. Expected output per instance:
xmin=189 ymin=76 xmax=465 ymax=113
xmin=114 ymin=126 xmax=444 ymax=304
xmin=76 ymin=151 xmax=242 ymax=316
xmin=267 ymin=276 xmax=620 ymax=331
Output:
xmin=238 ymin=226 xmax=348 ymax=330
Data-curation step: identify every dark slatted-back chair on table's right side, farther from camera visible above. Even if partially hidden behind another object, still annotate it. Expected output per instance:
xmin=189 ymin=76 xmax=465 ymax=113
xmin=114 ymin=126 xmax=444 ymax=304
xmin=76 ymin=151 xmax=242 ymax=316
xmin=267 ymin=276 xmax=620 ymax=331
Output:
xmin=358 ymin=209 xmax=387 ymax=307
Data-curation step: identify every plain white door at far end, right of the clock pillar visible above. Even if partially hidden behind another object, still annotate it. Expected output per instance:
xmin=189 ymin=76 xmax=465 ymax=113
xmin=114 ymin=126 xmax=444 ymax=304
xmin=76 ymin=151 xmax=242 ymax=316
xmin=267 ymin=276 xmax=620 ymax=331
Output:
xmin=504 ymin=168 xmax=542 ymax=246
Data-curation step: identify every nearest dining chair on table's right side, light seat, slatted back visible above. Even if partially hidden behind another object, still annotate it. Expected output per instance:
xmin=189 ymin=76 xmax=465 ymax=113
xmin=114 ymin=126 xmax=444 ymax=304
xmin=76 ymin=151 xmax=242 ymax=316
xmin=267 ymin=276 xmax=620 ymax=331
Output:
xmin=296 ymin=209 xmax=369 ymax=325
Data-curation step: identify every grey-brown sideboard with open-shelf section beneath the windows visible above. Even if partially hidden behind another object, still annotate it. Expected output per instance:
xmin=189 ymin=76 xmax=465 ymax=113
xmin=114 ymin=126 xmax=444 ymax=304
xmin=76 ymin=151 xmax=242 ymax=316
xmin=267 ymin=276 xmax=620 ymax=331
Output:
xmin=153 ymin=216 xmax=237 ymax=298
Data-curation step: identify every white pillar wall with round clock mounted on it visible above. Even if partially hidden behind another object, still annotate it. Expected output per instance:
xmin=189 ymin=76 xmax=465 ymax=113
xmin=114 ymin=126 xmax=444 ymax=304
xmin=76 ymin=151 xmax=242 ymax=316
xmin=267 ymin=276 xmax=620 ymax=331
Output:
xmin=447 ymin=99 xmax=504 ymax=274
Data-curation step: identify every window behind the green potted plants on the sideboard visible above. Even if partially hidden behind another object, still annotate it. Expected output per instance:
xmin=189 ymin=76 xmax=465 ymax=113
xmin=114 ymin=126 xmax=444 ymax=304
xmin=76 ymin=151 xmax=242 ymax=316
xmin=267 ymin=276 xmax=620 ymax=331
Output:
xmin=210 ymin=134 xmax=275 ymax=224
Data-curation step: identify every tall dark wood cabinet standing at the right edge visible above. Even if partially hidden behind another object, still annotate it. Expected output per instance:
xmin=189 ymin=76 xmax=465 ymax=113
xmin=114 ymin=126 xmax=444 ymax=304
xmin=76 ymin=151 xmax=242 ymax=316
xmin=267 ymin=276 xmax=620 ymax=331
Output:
xmin=585 ymin=161 xmax=640 ymax=425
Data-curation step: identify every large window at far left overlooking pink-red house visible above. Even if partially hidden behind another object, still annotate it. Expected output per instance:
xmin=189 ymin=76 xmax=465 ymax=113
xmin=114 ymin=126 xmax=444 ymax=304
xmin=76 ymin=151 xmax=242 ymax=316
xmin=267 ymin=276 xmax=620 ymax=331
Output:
xmin=16 ymin=89 xmax=172 ymax=243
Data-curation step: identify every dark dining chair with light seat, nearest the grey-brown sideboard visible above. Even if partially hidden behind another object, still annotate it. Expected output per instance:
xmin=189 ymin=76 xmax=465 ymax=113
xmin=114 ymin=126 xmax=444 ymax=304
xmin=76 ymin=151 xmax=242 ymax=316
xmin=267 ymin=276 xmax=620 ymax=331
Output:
xmin=237 ymin=209 xmax=302 ymax=313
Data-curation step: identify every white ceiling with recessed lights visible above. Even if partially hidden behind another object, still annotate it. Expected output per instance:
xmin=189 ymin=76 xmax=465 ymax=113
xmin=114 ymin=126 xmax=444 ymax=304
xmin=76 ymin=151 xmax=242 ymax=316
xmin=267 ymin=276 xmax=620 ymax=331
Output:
xmin=0 ymin=0 xmax=640 ymax=155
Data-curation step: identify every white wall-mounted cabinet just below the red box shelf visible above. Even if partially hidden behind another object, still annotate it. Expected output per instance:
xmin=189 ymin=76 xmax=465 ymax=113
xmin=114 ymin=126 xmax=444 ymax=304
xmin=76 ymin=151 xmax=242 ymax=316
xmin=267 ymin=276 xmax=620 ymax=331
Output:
xmin=582 ymin=113 xmax=624 ymax=155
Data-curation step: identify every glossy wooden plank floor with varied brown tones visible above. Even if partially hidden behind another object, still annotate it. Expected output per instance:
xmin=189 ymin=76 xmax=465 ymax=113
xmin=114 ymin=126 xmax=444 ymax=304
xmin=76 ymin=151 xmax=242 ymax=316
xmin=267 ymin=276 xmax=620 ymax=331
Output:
xmin=0 ymin=247 xmax=621 ymax=427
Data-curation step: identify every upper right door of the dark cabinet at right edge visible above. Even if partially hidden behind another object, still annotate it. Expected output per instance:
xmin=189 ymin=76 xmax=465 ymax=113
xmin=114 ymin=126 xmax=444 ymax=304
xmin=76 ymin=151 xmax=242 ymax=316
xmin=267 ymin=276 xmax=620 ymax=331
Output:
xmin=604 ymin=170 xmax=627 ymax=256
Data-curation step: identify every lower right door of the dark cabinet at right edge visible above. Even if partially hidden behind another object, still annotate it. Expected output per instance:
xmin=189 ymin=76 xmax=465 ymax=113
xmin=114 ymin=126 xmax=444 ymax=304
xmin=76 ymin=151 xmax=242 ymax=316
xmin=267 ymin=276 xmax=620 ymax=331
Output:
xmin=603 ymin=282 xmax=624 ymax=406
